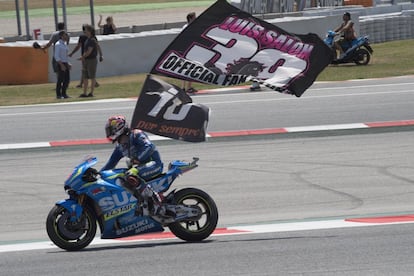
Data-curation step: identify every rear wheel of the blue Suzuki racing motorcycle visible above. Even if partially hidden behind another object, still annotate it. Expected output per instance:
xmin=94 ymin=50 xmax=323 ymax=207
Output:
xmin=168 ymin=188 xmax=218 ymax=242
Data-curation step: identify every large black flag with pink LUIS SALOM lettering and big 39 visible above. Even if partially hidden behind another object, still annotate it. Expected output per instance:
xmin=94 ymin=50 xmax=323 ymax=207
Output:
xmin=151 ymin=0 xmax=333 ymax=97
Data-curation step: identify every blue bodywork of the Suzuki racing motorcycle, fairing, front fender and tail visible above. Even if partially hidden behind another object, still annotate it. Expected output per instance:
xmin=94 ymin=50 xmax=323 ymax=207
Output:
xmin=56 ymin=157 xmax=198 ymax=239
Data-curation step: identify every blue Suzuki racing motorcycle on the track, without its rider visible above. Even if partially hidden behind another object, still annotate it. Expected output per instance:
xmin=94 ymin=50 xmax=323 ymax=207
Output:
xmin=46 ymin=157 xmax=218 ymax=251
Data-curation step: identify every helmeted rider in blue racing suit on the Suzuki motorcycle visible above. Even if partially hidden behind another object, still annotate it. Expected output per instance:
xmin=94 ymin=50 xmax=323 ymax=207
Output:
xmin=101 ymin=115 xmax=165 ymax=215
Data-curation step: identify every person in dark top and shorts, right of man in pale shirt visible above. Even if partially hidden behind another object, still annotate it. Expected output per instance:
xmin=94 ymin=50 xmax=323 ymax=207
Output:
xmin=79 ymin=25 xmax=103 ymax=98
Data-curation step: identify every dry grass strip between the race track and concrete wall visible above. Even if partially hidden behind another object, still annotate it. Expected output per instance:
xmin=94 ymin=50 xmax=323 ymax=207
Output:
xmin=0 ymin=39 xmax=414 ymax=106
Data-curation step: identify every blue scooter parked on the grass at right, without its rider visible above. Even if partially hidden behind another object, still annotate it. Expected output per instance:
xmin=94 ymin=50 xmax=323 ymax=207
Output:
xmin=324 ymin=30 xmax=374 ymax=65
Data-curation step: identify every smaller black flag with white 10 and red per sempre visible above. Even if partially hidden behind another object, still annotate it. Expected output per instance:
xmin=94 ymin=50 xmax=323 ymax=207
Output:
xmin=131 ymin=75 xmax=210 ymax=142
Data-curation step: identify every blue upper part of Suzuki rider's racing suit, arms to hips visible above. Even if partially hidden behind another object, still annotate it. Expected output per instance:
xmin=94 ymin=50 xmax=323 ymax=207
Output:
xmin=101 ymin=129 xmax=164 ymax=180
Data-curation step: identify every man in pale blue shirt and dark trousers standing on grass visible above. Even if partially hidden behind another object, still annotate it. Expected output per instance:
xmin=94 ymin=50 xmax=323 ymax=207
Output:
xmin=54 ymin=31 xmax=71 ymax=99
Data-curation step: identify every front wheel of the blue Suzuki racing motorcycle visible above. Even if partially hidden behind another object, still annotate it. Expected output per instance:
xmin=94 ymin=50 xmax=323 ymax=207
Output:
xmin=46 ymin=205 xmax=96 ymax=251
